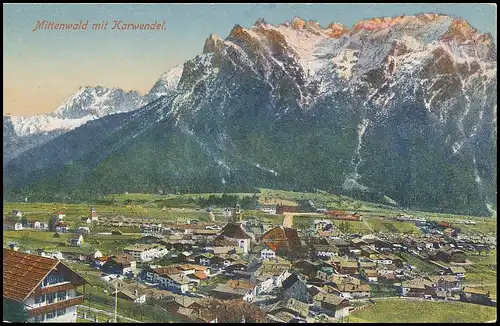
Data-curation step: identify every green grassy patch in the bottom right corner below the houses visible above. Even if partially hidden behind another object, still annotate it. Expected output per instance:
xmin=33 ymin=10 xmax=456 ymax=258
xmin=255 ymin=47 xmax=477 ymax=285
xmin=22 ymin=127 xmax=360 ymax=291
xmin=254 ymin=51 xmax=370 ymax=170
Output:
xmin=349 ymin=299 xmax=496 ymax=323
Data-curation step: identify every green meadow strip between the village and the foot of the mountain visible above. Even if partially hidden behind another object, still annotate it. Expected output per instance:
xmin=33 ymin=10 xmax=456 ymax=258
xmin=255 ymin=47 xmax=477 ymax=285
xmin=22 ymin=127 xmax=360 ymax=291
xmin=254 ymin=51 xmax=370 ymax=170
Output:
xmin=3 ymin=188 xmax=496 ymax=232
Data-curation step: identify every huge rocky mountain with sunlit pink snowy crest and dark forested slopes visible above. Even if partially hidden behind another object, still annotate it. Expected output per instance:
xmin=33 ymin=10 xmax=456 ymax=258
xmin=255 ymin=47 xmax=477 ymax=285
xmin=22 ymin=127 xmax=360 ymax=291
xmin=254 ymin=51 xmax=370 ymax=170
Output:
xmin=4 ymin=14 xmax=496 ymax=214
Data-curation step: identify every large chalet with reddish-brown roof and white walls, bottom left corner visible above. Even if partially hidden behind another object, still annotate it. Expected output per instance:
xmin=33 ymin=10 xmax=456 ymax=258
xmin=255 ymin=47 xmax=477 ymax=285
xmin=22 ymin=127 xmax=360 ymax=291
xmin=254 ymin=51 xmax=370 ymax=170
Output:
xmin=3 ymin=249 xmax=87 ymax=323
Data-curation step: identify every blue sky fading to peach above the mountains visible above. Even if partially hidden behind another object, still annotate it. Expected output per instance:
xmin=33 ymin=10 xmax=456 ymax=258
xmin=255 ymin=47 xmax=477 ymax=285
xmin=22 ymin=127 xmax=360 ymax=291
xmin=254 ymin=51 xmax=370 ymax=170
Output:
xmin=3 ymin=3 xmax=497 ymax=115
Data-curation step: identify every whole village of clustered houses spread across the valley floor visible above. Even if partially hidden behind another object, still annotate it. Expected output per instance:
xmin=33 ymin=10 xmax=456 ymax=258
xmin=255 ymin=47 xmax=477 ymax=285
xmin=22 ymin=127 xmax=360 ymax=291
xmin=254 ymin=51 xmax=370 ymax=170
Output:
xmin=4 ymin=199 xmax=496 ymax=323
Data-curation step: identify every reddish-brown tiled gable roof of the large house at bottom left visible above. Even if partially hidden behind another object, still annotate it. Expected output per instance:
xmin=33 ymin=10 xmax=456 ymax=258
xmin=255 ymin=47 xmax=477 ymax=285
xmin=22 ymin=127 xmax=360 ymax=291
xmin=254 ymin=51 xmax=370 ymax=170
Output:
xmin=3 ymin=248 xmax=86 ymax=301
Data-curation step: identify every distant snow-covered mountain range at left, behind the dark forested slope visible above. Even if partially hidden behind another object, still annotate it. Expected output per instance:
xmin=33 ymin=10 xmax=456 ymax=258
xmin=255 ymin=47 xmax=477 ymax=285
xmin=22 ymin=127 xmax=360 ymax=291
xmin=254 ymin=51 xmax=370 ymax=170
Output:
xmin=3 ymin=67 xmax=182 ymax=163
